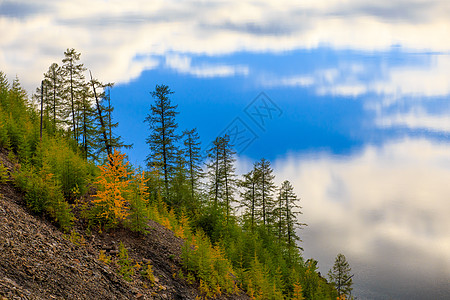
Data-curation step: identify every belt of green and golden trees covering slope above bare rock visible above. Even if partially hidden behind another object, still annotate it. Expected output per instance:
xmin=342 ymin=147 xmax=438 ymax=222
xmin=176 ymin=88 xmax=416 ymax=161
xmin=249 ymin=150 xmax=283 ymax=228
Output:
xmin=0 ymin=70 xmax=338 ymax=299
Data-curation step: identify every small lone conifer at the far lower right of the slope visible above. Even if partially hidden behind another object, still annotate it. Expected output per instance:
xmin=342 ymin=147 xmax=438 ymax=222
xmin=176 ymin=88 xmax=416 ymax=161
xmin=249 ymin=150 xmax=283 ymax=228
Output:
xmin=328 ymin=253 xmax=353 ymax=299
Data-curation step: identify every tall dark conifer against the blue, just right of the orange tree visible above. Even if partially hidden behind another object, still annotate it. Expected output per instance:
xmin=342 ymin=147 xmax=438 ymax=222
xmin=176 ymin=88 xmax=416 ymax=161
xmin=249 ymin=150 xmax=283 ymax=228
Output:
xmin=145 ymin=85 xmax=179 ymax=201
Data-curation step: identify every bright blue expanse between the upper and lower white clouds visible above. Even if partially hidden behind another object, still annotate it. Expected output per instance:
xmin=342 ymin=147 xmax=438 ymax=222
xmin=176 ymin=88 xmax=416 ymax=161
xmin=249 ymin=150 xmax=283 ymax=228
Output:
xmin=112 ymin=47 xmax=450 ymax=168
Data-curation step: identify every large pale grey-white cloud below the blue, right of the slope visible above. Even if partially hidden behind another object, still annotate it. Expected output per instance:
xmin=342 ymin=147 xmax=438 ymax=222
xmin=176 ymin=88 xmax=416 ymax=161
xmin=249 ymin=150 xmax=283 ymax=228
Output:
xmin=274 ymin=139 xmax=450 ymax=299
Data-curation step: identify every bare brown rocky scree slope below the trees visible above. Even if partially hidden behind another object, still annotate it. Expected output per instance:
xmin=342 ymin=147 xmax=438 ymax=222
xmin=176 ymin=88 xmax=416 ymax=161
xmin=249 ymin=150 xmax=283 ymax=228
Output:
xmin=0 ymin=150 xmax=248 ymax=300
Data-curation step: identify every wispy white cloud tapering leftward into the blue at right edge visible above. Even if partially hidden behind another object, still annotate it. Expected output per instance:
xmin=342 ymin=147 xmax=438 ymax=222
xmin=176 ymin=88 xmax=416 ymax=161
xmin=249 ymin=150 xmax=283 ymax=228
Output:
xmin=260 ymin=54 xmax=450 ymax=134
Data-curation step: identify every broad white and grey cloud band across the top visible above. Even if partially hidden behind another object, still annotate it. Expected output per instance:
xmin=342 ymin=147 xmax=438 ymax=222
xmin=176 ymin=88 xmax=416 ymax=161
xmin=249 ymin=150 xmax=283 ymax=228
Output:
xmin=0 ymin=0 xmax=450 ymax=93
